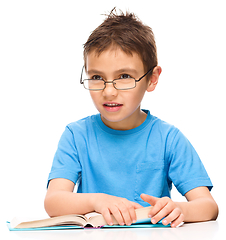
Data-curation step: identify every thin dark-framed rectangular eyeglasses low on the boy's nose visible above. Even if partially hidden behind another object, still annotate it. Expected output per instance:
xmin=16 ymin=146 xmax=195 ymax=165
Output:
xmin=80 ymin=66 xmax=155 ymax=91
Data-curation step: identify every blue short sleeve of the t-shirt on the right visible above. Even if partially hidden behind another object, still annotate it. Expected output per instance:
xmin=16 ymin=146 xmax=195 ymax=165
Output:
xmin=168 ymin=130 xmax=213 ymax=195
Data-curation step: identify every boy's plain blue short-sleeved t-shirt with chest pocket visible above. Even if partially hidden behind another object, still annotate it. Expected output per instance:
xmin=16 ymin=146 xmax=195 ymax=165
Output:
xmin=48 ymin=110 xmax=212 ymax=206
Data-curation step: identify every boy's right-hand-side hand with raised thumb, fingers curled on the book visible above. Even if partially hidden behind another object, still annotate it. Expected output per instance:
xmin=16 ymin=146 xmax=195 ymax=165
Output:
xmin=141 ymin=194 xmax=184 ymax=227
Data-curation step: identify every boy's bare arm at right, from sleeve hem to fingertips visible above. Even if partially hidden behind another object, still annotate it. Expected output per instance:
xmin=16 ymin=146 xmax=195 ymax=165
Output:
xmin=141 ymin=187 xmax=218 ymax=227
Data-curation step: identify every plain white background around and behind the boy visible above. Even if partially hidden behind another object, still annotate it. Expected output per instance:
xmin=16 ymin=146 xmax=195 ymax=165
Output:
xmin=0 ymin=0 xmax=226 ymax=230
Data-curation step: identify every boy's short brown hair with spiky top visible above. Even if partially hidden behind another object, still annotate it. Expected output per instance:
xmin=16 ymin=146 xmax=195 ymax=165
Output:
xmin=83 ymin=8 xmax=158 ymax=71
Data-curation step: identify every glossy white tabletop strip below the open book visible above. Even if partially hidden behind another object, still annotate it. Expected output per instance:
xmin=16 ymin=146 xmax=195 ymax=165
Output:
xmin=0 ymin=221 xmax=225 ymax=240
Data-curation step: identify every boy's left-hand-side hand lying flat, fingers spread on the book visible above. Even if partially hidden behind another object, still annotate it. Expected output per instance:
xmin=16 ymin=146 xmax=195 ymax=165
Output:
xmin=93 ymin=193 xmax=142 ymax=225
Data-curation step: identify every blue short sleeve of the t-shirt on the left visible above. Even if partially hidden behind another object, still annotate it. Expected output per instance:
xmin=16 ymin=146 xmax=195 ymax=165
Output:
xmin=47 ymin=127 xmax=81 ymax=187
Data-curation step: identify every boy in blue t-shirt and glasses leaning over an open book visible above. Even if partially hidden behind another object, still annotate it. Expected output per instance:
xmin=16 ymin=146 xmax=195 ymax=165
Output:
xmin=45 ymin=8 xmax=218 ymax=227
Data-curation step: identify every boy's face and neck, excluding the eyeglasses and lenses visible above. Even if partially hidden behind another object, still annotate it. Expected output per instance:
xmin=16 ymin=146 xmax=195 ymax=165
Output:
xmin=86 ymin=48 xmax=160 ymax=130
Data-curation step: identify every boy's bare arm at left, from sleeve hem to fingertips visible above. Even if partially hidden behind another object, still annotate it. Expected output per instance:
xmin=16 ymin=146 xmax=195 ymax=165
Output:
xmin=45 ymin=178 xmax=142 ymax=225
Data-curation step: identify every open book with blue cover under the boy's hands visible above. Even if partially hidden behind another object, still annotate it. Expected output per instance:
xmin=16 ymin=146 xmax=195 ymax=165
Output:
xmin=8 ymin=206 xmax=170 ymax=231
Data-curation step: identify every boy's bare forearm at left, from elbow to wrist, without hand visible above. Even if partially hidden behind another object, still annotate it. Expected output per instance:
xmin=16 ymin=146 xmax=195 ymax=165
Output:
xmin=45 ymin=190 xmax=96 ymax=217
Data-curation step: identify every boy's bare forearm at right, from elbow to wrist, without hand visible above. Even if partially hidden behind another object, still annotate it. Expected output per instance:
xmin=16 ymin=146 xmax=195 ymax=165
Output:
xmin=176 ymin=197 xmax=218 ymax=222
